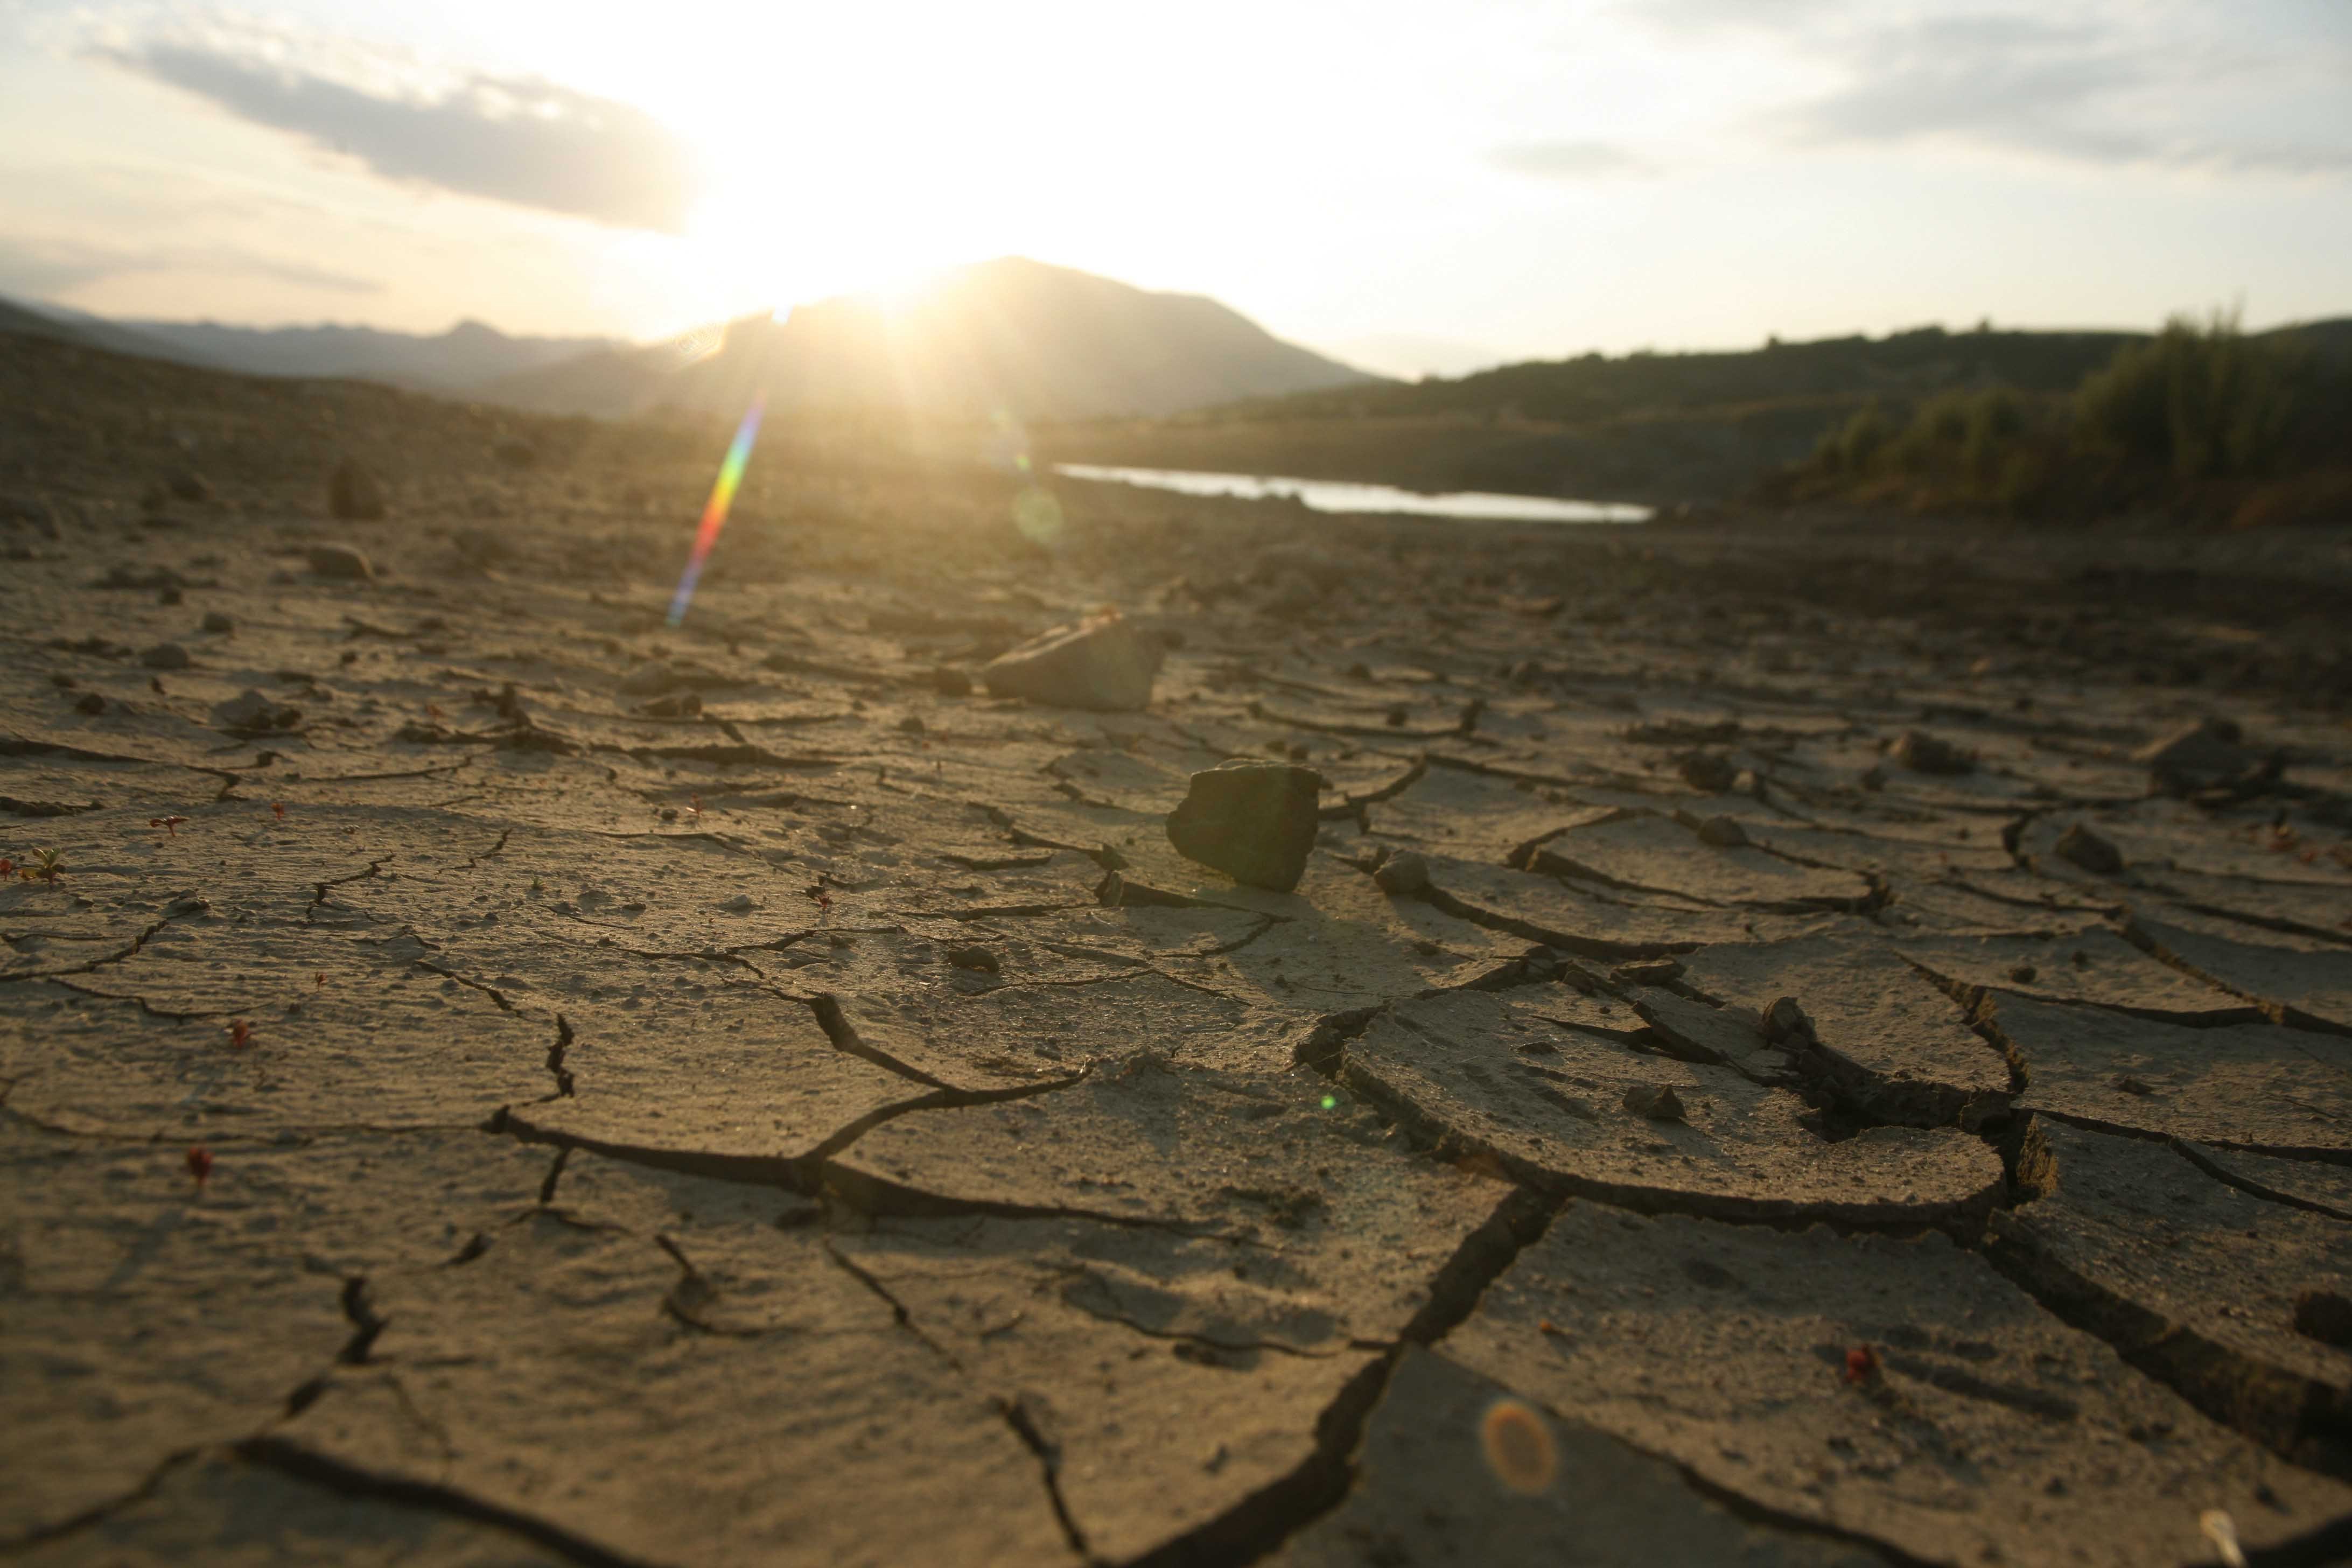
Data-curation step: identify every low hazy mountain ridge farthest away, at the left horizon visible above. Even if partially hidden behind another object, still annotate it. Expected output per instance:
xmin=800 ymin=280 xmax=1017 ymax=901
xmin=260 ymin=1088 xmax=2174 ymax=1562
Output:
xmin=120 ymin=320 xmax=616 ymax=393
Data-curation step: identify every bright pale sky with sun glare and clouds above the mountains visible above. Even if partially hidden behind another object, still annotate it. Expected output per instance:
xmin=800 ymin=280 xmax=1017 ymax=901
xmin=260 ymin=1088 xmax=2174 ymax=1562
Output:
xmin=0 ymin=0 xmax=2352 ymax=374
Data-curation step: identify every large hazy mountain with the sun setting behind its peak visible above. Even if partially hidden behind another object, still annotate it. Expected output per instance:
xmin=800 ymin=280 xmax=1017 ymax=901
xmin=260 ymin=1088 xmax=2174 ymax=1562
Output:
xmin=475 ymin=256 xmax=1383 ymax=421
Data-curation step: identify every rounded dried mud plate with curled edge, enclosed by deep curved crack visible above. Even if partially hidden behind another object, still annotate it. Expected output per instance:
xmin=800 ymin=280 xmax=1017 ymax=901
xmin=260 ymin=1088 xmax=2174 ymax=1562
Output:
xmin=1341 ymin=988 xmax=2001 ymax=1225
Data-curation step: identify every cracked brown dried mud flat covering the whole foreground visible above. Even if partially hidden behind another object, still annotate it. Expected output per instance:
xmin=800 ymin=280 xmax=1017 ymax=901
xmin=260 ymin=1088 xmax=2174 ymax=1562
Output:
xmin=0 ymin=324 xmax=2352 ymax=1566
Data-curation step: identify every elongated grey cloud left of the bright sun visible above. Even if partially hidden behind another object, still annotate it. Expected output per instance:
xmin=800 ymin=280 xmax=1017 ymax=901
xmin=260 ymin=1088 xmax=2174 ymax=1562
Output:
xmin=96 ymin=40 xmax=696 ymax=233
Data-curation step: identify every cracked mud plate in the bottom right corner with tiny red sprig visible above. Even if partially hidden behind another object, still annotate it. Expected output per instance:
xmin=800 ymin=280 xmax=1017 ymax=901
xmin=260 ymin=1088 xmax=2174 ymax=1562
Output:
xmin=1444 ymin=1201 xmax=2352 ymax=1568
